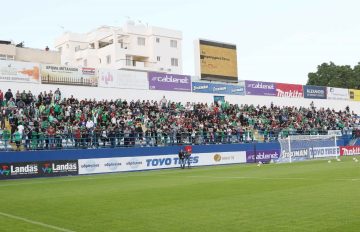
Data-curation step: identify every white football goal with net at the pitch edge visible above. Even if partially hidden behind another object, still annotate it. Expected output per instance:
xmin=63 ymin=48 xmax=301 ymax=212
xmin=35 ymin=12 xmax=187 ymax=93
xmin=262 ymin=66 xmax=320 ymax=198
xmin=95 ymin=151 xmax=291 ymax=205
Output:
xmin=279 ymin=135 xmax=340 ymax=163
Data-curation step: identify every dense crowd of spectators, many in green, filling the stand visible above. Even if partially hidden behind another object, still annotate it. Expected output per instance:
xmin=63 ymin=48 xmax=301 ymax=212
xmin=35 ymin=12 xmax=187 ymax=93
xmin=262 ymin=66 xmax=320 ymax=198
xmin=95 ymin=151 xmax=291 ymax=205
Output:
xmin=0 ymin=89 xmax=359 ymax=149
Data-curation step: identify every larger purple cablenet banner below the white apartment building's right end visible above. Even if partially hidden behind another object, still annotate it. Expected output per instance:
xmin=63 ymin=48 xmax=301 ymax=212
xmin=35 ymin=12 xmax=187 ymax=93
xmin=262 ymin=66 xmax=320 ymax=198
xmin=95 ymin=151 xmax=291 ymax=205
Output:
xmin=148 ymin=72 xmax=191 ymax=92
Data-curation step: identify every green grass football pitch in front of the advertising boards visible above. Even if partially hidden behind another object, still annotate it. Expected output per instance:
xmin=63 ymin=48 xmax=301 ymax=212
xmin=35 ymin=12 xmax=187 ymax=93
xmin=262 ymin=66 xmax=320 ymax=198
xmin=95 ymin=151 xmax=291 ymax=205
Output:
xmin=0 ymin=157 xmax=360 ymax=232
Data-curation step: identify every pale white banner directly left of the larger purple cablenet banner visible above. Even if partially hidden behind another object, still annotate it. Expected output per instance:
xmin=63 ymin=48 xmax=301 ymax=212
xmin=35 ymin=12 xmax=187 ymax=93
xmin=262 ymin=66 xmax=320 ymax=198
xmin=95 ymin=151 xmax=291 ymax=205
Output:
xmin=99 ymin=69 xmax=149 ymax=90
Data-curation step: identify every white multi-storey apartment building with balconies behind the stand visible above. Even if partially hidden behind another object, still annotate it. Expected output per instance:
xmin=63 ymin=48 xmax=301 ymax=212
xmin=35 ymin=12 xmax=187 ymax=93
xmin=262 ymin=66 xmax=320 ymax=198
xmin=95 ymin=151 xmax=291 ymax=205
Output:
xmin=55 ymin=21 xmax=182 ymax=74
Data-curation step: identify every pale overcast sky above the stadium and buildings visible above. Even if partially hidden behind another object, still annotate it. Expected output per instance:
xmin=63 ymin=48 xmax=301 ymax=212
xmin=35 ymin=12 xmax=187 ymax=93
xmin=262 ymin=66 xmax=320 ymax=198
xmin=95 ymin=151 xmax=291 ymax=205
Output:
xmin=0 ymin=0 xmax=360 ymax=84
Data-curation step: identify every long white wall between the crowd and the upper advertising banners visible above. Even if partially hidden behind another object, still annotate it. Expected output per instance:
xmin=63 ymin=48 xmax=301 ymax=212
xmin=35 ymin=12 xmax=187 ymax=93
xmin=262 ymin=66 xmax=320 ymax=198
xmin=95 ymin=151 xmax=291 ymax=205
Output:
xmin=0 ymin=82 xmax=360 ymax=114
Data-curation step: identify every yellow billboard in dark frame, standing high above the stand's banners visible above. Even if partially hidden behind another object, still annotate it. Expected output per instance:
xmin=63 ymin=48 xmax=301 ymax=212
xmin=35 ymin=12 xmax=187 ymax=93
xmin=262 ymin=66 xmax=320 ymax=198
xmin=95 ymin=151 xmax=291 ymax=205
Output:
xmin=199 ymin=40 xmax=238 ymax=82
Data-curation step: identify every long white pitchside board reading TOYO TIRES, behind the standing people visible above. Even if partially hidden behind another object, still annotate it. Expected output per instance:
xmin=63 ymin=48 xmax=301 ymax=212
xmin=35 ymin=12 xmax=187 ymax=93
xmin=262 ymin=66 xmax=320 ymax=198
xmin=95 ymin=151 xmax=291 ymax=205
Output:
xmin=79 ymin=151 xmax=246 ymax=174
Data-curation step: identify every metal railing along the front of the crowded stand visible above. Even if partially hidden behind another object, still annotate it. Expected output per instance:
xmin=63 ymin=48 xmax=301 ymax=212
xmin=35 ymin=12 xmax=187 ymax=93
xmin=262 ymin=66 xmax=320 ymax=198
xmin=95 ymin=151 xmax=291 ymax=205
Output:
xmin=0 ymin=130 xmax=360 ymax=151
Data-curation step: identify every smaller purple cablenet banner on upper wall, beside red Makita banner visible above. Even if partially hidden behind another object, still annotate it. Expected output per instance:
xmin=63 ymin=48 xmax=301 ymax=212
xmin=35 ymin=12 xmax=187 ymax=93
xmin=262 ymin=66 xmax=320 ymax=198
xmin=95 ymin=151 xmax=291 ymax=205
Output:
xmin=245 ymin=81 xmax=277 ymax=96
